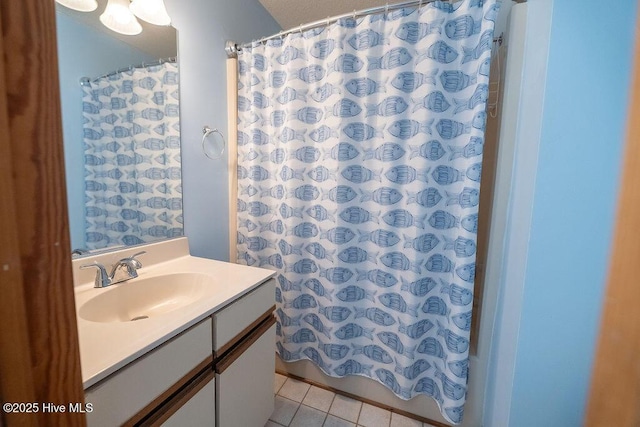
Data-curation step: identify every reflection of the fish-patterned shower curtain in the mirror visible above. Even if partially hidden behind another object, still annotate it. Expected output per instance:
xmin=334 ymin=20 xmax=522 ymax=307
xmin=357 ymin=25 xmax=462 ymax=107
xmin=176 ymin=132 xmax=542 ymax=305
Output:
xmin=82 ymin=62 xmax=183 ymax=249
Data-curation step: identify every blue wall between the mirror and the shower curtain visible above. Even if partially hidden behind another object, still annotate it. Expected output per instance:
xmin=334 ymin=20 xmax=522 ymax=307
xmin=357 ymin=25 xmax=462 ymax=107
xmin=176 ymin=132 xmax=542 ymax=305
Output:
xmin=165 ymin=0 xmax=280 ymax=261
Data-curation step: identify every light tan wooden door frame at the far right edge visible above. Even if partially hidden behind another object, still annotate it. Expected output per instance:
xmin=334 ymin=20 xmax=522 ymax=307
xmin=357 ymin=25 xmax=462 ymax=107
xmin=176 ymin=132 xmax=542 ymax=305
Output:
xmin=585 ymin=4 xmax=640 ymax=427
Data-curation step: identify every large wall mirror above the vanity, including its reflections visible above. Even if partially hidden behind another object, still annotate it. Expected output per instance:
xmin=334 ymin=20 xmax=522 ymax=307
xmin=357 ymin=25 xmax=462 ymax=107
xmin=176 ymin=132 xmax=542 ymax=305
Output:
xmin=56 ymin=0 xmax=183 ymax=256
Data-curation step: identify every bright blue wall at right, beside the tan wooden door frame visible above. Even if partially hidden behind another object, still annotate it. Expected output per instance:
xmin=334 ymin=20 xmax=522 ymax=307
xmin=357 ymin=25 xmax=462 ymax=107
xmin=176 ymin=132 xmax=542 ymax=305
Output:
xmin=507 ymin=0 xmax=636 ymax=427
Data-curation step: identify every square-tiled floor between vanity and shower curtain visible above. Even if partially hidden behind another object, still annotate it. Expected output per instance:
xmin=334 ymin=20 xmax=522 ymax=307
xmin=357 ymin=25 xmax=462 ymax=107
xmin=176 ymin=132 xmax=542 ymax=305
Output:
xmin=265 ymin=374 xmax=438 ymax=427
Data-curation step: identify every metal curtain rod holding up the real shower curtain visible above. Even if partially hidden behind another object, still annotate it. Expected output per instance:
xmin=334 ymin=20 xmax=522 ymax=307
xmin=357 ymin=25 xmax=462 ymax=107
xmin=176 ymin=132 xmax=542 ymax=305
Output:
xmin=224 ymin=0 xmax=510 ymax=58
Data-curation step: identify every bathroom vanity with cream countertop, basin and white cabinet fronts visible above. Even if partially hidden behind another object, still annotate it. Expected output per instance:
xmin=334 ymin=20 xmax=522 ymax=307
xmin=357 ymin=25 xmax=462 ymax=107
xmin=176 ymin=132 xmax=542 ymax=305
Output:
xmin=73 ymin=238 xmax=275 ymax=427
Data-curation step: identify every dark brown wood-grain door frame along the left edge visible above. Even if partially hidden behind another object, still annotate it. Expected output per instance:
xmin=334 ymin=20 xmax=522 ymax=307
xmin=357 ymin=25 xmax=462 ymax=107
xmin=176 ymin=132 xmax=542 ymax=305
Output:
xmin=0 ymin=0 xmax=86 ymax=426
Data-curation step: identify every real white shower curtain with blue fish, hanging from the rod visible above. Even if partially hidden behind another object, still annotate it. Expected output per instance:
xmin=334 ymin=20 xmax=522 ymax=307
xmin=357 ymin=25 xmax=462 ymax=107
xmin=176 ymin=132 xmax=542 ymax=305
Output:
xmin=238 ymin=0 xmax=499 ymax=423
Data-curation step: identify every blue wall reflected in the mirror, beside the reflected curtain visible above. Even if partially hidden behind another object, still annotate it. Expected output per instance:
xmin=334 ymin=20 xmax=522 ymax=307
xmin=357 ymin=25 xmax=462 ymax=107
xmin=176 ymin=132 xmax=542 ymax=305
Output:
xmin=56 ymin=11 xmax=157 ymax=248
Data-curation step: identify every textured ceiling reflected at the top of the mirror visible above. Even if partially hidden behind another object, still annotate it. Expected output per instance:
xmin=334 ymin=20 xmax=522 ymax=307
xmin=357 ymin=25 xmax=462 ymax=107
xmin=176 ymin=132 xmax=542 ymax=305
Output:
xmin=56 ymin=0 xmax=178 ymax=59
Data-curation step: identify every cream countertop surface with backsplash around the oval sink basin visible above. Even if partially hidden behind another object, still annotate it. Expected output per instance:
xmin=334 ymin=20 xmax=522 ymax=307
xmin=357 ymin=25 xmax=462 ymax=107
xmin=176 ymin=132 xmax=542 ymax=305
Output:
xmin=73 ymin=238 xmax=275 ymax=389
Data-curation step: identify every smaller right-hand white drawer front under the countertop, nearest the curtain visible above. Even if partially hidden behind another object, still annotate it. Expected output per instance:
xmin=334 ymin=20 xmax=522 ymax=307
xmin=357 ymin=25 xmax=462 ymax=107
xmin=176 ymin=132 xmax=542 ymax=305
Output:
xmin=213 ymin=279 xmax=276 ymax=357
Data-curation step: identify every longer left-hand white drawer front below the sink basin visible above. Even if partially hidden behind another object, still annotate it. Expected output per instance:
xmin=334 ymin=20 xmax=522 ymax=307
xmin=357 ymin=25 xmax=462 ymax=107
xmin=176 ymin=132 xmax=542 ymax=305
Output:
xmin=85 ymin=318 xmax=212 ymax=426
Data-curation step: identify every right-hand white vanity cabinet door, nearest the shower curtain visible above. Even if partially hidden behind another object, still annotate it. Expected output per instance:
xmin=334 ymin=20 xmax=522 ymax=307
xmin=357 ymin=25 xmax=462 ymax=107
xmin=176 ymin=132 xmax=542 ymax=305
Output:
xmin=216 ymin=319 xmax=276 ymax=427
